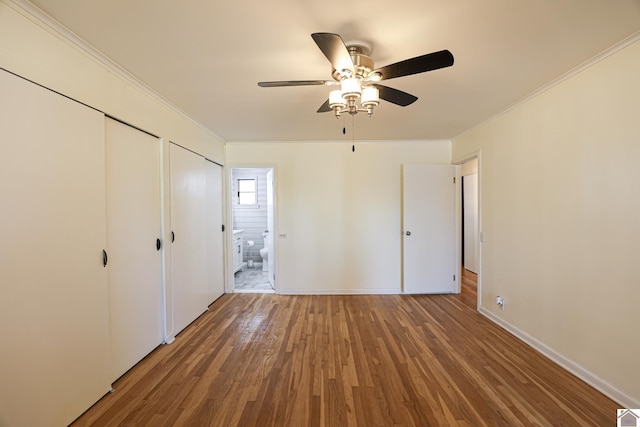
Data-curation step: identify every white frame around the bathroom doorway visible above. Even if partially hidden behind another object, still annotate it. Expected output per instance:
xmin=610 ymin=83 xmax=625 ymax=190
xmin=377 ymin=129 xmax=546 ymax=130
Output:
xmin=223 ymin=163 xmax=279 ymax=294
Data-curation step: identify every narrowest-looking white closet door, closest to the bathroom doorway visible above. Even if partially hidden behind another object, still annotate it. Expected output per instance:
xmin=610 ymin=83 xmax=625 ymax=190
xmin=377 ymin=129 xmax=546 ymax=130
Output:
xmin=205 ymin=161 xmax=224 ymax=303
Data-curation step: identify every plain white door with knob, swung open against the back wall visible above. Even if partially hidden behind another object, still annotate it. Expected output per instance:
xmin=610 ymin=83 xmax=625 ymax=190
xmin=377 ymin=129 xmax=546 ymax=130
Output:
xmin=402 ymin=165 xmax=459 ymax=294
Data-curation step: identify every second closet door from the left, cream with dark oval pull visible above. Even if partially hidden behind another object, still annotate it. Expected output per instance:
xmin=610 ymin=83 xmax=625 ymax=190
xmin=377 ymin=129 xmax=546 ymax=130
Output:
xmin=105 ymin=118 xmax=164 ymax=381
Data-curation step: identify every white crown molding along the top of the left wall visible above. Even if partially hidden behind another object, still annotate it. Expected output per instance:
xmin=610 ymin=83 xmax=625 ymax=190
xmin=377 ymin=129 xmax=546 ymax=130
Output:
xmin=2 ymin=0 xmax=224 ymax=142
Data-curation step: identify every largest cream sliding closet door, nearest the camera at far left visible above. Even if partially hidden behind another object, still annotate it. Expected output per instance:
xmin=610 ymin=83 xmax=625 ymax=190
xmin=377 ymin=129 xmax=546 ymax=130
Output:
xmin=0 ymin=70 xmax=110 ymax=426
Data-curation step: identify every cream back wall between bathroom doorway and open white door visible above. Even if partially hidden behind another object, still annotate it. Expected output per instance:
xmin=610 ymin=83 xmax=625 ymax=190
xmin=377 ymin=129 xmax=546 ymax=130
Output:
xmin=227 ymin=141 xmax=451 ymax=293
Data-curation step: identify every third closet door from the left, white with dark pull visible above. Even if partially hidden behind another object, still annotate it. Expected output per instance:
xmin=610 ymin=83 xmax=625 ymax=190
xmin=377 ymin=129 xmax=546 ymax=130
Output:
xmin=169 ymin=144 xmax=208 ymax=334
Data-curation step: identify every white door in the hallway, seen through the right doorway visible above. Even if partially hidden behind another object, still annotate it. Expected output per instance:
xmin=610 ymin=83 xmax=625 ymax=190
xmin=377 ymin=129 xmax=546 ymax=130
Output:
xmin=462 ymin=173 xmax=479 ymax=273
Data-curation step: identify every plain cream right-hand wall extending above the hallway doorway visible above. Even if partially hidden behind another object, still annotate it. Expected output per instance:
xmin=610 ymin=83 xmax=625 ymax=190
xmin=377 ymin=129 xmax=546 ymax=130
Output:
xmin=452 ymin=37 xmax=640 ymax=407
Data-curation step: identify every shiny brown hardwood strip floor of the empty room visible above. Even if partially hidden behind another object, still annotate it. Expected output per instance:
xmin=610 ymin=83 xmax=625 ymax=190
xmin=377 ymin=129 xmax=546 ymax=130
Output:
xmin=73 ymin=272 xmax=618 ymax=427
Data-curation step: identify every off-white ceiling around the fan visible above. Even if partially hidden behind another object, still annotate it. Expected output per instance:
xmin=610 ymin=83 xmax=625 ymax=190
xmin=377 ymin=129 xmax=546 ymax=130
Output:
xmin=27 ymin=0 xmax=640 ymax=141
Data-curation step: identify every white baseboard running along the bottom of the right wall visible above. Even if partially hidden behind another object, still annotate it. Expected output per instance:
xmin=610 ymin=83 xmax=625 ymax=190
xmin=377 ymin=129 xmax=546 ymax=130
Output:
xmin=478 ymin=307 xmax=640 ymax=408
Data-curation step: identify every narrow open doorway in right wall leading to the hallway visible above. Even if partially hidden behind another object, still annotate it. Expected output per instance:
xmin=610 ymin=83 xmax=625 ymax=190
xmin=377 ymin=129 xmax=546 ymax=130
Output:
xmin=460 ymin=155 xmax=481 ymax=308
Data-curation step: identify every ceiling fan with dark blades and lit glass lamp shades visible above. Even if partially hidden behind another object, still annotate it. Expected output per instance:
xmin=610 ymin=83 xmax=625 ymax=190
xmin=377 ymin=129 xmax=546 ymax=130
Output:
xmin=258 ymin=33 xmax=453 ymax=117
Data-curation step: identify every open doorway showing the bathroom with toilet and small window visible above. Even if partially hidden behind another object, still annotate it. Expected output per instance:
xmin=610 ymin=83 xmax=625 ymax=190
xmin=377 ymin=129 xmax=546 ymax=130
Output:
xmin=230 ymin=168 xmax=275 ymax=293
